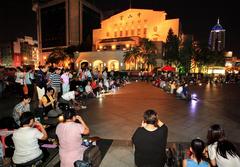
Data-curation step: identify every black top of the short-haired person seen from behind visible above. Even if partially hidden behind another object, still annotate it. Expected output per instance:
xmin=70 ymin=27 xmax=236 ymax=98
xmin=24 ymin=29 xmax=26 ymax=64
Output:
xmin=132 ymin=125 xmax=168 ymax=167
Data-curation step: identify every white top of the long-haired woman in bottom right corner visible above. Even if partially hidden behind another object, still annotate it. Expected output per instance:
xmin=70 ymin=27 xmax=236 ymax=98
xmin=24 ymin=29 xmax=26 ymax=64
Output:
xmin=208 ymin=142 xmax=240 ymax=167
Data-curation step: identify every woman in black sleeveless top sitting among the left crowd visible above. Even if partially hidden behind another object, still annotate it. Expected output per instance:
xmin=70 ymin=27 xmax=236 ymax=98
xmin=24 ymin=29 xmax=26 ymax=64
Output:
xmin=42 ymin=87 xmax=59 ymax=119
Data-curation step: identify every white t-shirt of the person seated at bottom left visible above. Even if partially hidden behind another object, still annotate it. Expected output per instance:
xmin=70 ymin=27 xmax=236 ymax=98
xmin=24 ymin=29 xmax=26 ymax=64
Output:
xmin=12 ymin=127 xmax=43 ymax=164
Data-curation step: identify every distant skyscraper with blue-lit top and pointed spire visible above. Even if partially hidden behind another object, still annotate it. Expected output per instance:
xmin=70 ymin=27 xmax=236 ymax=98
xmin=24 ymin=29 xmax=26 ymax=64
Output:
xmin=208 ymin=18 xmax=225 ymax=51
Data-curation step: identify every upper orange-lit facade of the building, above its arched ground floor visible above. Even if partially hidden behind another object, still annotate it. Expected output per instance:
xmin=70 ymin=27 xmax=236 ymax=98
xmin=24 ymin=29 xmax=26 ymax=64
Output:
xmin=93 ymin=9 xmax=180 ymax=50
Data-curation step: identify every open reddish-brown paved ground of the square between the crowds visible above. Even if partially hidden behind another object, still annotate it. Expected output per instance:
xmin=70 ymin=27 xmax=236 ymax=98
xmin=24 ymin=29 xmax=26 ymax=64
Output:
xmin=0 ymin=82 xmax=240 ymax=167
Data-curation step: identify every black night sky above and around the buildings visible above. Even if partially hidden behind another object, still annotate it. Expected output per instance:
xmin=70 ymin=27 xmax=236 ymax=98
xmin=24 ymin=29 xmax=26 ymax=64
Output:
xmin=0 ymin=0 xmax=240 ymax=55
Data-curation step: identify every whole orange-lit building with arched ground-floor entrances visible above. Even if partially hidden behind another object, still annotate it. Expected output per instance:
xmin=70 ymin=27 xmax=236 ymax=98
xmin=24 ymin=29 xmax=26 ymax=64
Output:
xmin=76 ymin=9 xmax=181 ymax=71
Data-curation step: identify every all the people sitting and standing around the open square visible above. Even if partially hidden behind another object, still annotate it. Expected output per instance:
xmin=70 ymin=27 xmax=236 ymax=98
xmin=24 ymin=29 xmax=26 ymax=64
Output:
xmin=0 ymin=66 xmax=240 ymax=167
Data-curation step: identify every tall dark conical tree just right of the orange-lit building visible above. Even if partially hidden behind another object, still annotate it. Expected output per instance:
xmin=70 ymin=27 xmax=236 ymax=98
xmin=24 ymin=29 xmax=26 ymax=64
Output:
xmin=164 ymin=28 xmax=179 ymax=64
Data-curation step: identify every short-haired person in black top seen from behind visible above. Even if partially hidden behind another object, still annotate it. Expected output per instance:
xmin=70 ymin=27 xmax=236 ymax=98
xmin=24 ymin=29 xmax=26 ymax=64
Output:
xmin=132 ymin=110 xmax=168 ymax=167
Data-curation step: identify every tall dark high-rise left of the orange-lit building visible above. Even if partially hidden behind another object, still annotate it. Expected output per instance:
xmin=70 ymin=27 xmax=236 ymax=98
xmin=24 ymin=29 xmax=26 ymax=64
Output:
xmin=32 ymin=0 xmax=102 ymax=64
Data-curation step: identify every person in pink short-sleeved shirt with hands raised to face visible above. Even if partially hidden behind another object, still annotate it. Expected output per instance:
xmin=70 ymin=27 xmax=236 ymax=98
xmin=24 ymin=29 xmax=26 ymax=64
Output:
xmin=56 ymin=109 xmax=89 ymax=167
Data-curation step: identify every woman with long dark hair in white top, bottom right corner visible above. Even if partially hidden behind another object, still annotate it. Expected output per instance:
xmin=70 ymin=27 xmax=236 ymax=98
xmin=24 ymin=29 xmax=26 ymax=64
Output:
xmin=207 ymin=124 xmax=240 ymax=167
